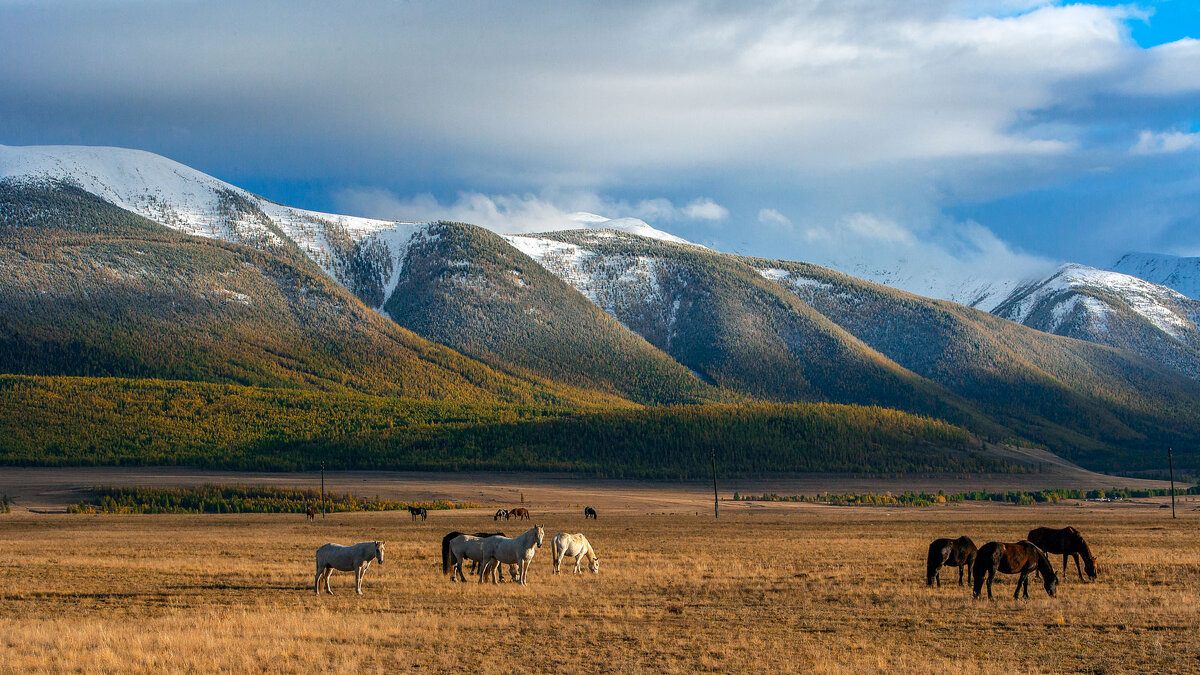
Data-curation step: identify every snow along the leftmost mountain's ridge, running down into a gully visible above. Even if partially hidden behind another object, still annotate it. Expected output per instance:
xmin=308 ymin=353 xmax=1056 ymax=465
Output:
xmin=0 ymin=145 xmax=427 ymax=307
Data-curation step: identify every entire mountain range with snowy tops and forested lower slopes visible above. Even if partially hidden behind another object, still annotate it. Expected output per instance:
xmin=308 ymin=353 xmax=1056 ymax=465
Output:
xmin=0 ymin=147 xmax=1200 ymax=477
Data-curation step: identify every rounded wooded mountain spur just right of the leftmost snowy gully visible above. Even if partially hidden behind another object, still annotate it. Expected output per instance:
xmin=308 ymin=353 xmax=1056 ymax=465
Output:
xmin=385 ymin=223 xmax=731 ymax=404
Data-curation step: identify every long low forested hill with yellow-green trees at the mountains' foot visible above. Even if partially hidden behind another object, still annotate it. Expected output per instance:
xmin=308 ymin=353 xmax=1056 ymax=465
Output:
xmin=0 ymin=376 xmax=1008 ymax=478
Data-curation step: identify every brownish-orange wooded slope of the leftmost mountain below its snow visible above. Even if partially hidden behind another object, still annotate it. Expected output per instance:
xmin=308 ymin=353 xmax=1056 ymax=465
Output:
xmin=0 ymin=184 xmax=619 ymax=405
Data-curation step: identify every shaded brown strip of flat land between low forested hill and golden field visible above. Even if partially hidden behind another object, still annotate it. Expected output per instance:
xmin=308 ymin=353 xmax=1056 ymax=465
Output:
xmin=0 ymin=447 xmax=1168 ymax=513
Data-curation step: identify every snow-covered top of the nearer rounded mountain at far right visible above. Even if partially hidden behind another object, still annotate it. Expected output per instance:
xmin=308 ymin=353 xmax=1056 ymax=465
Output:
xmin=994 ymin=263 xmax=1200 ymax=341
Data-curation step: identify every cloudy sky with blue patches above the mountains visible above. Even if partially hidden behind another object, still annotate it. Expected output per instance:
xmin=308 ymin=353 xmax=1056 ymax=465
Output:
xmin=0 ymin=0 xmax=1200 ymax=289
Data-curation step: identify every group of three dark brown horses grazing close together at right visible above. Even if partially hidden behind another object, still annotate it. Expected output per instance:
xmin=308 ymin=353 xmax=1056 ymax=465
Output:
xmin=925 ymin=527 xmax=1097 ymax=599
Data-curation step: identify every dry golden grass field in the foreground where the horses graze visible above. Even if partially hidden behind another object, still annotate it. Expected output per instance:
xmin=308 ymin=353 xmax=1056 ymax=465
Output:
xmin=0 ymin=492 xmax=1200 ymax=673
